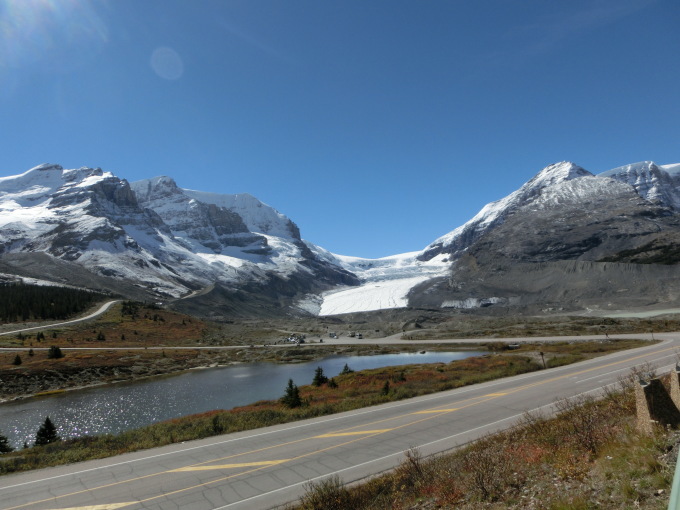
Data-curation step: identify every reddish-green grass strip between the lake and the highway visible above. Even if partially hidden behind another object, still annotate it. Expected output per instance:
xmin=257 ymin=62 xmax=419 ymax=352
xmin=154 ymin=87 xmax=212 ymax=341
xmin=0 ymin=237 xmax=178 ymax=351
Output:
xmin=0 ymin=342 xmax=649 ymax=474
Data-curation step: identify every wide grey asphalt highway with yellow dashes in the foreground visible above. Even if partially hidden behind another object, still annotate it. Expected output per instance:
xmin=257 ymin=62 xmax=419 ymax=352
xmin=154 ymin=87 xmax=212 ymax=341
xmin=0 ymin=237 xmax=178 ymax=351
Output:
xmin=0 ymin=333 xmax=680 ymax=510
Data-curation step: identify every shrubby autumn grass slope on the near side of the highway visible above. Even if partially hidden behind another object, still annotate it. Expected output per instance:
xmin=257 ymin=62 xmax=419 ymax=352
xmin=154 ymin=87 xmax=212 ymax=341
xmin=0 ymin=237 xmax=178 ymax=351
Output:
xmin=294 ymin=372 xmax=680 ymax=510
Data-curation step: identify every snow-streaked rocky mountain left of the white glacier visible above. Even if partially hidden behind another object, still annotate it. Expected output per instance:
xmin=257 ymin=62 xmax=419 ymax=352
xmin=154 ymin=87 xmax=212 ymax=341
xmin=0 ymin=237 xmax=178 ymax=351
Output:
xmin=0 ymin=165 xmax=357 ymax=314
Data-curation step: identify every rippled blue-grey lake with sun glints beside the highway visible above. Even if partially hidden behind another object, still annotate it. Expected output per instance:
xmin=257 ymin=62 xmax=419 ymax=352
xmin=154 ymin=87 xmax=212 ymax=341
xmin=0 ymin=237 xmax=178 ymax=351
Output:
xmin=0 ymin=351 xmax=483 ymax=447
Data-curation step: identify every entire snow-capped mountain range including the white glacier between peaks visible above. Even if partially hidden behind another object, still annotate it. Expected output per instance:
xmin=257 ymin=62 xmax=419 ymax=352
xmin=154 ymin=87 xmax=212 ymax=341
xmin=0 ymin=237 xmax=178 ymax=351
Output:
xmin=0 ymin=162 xmax=680 ymax=317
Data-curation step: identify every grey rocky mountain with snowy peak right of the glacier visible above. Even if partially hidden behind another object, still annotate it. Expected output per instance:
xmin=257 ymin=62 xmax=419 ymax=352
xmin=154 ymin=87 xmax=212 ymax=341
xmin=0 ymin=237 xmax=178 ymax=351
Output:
xmin=409 ymin=162 xmax=680 ymax=310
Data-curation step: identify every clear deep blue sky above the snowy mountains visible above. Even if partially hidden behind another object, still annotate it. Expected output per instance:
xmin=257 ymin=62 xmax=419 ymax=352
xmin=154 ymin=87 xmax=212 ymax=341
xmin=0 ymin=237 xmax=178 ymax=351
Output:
xmin=0 ymin=0 xmax=680 ymax=257
